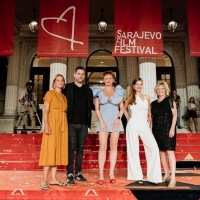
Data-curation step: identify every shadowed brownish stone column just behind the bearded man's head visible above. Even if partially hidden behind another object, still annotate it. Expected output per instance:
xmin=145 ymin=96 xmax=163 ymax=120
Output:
xmin=66 ymin=58 xmax=80 ymax=83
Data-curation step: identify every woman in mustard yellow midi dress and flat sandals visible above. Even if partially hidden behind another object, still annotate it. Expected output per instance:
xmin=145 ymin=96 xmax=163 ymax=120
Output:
xmin=39 ymin=74 xmax=68 ymax=190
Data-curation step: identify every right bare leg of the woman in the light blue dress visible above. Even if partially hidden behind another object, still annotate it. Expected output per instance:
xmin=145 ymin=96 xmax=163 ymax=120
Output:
xmin=109 ymin=132 xmax=119 ymax=179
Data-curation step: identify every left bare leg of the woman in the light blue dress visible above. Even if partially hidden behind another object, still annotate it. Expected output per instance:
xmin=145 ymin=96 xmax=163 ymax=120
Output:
xmin=98 ymin=132 xmax=108 ymax=180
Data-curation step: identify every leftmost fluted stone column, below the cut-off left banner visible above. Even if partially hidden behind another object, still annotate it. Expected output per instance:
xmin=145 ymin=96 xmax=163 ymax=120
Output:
xmin=4 ymin=39 xmax=20 ymax=115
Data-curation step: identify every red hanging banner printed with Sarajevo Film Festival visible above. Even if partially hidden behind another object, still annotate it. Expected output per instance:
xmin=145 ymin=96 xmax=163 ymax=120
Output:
xmin=112 ymin=0 xmax=163 ymax=57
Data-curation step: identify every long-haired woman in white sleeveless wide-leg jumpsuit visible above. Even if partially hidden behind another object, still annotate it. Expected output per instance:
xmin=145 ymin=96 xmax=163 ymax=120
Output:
xmin=124 ymin=78 xmax=162 ymax=184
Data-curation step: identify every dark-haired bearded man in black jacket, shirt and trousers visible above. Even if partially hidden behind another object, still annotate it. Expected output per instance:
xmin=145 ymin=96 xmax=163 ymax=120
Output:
xmin=63 ymin=66 xmax=94 ymax=185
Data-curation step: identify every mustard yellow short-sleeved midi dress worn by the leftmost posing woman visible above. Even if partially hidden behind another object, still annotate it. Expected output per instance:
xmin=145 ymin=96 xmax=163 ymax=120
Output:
xmin=39 ymin=90 xmax=68 ymax=166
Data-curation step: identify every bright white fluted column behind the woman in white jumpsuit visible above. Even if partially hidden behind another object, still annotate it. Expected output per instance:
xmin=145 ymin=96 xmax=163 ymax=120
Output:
xmin=139 ymin=57 xmax=157 ymax=101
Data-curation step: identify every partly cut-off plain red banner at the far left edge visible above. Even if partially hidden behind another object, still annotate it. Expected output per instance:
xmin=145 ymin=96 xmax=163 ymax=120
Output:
xmin=0 ymin=0 xmax=15 ymax=56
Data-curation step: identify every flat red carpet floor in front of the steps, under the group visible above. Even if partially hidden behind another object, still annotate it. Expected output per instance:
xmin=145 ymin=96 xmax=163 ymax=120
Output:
xmin=0 ymin=170 xmax=200 ymax=200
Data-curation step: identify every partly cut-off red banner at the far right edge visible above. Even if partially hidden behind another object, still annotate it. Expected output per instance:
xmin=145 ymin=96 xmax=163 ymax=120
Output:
xmin=186 ymin=0 xmax=200 ymax=56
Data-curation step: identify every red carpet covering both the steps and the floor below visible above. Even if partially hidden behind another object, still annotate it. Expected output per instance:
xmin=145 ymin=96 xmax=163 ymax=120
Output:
xmin=0 ymin=133 xmax=200 ymax=200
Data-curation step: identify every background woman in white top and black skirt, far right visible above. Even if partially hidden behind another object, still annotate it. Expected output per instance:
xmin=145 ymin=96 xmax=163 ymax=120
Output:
xmin=188 ymin=97 xmax=199 ymax=132
